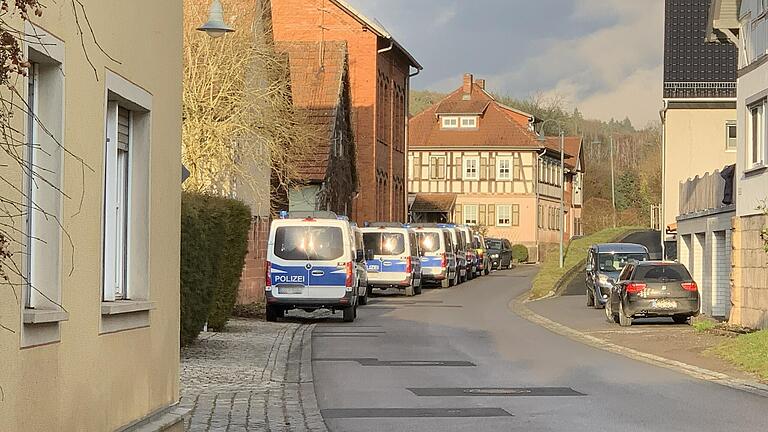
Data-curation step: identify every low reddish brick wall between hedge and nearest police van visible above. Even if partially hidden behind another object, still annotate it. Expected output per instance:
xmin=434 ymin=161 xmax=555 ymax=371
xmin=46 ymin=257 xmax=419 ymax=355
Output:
xmin=237 ymin=217 xmax=269 ymax=304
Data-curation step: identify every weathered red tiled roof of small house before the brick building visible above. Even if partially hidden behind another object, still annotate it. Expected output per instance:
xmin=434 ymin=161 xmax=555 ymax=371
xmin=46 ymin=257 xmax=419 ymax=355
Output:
xmin=275 ymin=41 xmax=347 ymax=182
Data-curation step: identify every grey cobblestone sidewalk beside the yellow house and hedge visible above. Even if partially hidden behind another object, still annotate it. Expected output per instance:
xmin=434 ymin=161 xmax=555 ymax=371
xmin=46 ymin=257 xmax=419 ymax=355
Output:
xmin=180 ymin=319 xmax=327 ymax=432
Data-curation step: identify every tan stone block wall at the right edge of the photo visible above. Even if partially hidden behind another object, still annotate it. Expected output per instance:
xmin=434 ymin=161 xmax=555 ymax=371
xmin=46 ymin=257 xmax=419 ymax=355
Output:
xmin=730 ymin=215 xmax=768 ymax=328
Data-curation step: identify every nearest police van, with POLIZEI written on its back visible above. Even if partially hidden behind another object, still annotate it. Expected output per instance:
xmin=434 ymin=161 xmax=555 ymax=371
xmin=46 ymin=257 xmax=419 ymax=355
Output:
xmin=265 ymin=212 xmax=365 ymax=322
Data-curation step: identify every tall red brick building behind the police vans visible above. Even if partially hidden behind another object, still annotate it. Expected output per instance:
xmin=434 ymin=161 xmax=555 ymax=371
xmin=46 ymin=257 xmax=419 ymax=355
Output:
xmin=272 ymin=0 xmax=421 ymax=224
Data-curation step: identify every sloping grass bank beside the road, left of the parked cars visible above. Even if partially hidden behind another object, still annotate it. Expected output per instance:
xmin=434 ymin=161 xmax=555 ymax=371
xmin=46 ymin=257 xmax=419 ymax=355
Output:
xmin=530 ymin=227 xmax=640 ymax=299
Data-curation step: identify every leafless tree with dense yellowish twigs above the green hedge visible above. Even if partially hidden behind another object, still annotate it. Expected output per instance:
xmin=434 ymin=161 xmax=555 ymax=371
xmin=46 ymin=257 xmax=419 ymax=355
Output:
xmin=182 ymin=0 xmax=314 ymax=202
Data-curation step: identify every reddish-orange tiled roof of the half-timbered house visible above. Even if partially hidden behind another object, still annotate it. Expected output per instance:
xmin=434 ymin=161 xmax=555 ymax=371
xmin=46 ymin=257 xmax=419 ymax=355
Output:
xmin=408 ymin=83 xmax=541 ymax=149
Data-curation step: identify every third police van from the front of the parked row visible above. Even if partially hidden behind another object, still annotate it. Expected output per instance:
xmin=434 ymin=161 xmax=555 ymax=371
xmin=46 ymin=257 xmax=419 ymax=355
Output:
xmin=413 ymin=225 xmax=456 ymax=288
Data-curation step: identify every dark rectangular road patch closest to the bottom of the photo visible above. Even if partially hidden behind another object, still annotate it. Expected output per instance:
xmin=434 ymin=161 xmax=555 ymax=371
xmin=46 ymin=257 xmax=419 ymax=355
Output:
xmin=320 ymin=408 xmax=512 ymax=419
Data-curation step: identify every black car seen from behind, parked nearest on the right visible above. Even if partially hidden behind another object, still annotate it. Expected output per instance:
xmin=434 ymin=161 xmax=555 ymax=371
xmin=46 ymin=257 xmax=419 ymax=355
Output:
xmin=605 ymin=261 xmax=700 ymax=327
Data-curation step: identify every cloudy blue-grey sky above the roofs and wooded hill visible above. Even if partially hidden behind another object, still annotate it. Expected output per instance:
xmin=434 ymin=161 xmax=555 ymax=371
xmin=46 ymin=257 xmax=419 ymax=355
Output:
xmin=347 ymin=0 xmax=664 ymax=126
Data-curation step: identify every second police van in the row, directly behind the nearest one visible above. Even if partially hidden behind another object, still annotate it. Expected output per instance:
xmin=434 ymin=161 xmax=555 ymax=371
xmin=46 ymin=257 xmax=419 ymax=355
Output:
xmin=361 ymin=223 xmax=422 ymax=296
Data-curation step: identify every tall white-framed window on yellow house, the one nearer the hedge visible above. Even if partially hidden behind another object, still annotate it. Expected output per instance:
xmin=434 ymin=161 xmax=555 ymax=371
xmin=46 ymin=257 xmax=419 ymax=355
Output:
xmin=102 ymin=71 xmax=152 ymax=302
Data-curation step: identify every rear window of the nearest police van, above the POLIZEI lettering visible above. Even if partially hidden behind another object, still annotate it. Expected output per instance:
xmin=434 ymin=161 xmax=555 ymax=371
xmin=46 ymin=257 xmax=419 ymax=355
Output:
xmin=274 ymin=226 xmax=344 ymax=261
